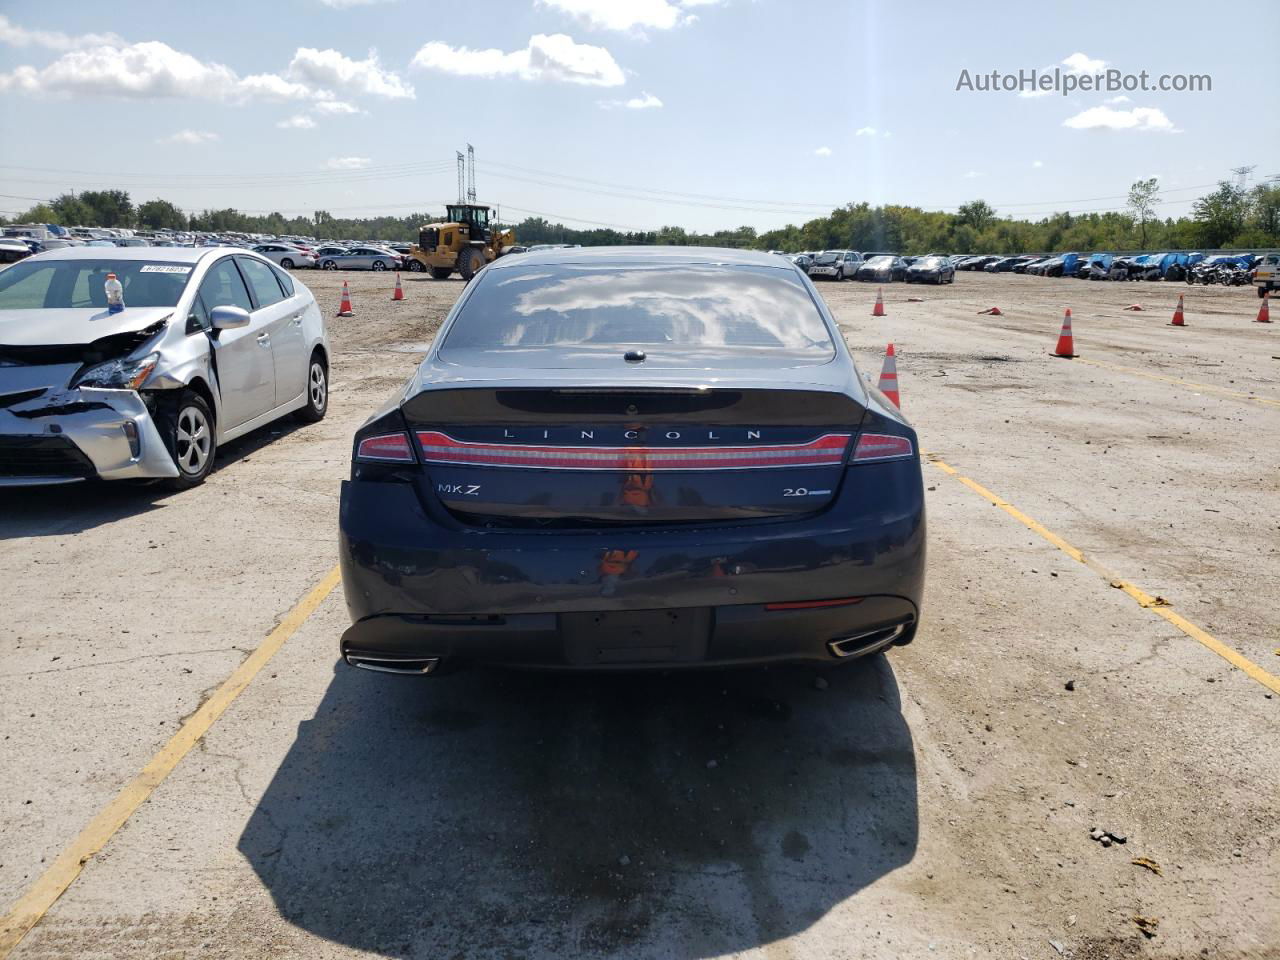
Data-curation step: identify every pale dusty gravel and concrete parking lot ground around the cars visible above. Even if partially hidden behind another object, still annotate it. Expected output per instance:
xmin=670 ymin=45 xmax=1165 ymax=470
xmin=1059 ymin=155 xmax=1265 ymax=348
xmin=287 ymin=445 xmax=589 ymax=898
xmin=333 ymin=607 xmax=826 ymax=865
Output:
xmin=0 ymin=273 xmax=1280 ymax=960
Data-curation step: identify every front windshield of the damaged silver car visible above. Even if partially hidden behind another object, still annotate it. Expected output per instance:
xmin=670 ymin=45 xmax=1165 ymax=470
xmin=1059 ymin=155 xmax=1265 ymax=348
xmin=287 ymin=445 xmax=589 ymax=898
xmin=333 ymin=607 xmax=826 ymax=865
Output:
xmin=0 ymin=257 xmax=193 ymax=310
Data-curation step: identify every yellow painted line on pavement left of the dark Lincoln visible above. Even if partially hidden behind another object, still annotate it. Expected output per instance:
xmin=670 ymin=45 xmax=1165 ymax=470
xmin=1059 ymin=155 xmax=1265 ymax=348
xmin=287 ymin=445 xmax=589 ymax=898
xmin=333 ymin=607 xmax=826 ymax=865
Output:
xmin=0 ymin=567 xmax=340 ymax=960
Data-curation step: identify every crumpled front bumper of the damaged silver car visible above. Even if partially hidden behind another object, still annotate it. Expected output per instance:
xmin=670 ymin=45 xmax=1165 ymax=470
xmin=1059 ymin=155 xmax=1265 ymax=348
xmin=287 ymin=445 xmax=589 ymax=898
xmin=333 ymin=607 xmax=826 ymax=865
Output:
xmin=0 ymin=387 xmax=178 ymax=486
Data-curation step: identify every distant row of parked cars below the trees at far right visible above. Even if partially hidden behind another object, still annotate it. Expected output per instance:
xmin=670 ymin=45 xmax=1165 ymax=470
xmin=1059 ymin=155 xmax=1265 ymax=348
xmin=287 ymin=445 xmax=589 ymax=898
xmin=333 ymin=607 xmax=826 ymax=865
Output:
xmin=956 ymin=253 xmax=1280 ymax=297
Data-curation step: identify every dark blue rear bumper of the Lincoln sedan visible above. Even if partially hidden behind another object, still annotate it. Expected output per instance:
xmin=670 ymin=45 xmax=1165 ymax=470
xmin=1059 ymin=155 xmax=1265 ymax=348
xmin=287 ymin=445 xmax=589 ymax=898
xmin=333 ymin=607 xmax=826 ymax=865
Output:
xmin=339 ymin=461 xmax=925 ymax=669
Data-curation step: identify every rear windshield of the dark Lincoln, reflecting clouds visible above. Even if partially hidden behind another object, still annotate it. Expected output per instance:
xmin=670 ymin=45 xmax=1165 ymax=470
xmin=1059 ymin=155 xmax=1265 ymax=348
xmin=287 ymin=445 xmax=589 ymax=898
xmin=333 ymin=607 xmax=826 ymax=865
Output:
xmin=443 ymin=264 xmax=835 ymax=361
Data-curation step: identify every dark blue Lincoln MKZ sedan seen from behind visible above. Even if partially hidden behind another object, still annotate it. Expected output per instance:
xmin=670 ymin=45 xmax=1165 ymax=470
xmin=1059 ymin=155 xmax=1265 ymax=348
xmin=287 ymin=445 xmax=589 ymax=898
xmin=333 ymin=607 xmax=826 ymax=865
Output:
xmin=339 ymin=247 xmax=925 ymax=675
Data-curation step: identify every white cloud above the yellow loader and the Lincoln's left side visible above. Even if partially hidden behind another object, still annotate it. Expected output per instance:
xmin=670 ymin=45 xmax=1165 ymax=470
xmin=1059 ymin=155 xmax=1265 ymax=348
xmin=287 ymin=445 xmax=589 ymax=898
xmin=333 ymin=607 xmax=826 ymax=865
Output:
xmin=410 ymin=33 xmax=626 ymax=87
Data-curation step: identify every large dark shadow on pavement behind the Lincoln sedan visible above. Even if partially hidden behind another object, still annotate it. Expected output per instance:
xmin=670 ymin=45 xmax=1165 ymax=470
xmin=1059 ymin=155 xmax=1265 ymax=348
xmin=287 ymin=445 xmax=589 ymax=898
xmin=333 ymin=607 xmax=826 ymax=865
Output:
xmin=238 ymin=657 xmax=918 ymax=957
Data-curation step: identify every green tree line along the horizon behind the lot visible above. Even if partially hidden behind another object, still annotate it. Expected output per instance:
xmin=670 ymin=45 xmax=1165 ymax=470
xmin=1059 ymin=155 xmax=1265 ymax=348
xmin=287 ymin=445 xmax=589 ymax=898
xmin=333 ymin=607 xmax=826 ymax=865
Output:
xmin=5 ymin=180 xmax=1280 ymax=253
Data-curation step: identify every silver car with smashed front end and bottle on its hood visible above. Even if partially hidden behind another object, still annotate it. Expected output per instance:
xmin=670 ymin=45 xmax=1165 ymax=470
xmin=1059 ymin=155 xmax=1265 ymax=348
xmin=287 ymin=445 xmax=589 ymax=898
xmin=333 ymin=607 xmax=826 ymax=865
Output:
xmin=0 ymin=247 xmax=329 ymax=489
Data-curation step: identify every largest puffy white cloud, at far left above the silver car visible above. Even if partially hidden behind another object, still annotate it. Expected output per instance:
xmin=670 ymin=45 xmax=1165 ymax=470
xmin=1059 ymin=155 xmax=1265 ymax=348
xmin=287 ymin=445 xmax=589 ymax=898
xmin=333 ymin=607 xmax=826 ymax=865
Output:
xmin=0 ymin=40 xmax=318 ymax=102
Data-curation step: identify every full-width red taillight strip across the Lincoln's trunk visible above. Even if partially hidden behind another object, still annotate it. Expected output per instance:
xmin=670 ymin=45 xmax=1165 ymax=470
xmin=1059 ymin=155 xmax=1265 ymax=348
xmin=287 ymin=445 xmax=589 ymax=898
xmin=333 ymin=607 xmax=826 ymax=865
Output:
xmin=417 ymin=430 xmax=850 ymax=472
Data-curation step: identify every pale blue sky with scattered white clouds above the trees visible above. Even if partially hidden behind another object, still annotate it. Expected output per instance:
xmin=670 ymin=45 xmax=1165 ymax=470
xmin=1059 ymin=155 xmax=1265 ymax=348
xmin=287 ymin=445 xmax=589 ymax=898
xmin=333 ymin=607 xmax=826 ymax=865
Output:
xmin=0 ymin=0 xmax=1280 ymax=229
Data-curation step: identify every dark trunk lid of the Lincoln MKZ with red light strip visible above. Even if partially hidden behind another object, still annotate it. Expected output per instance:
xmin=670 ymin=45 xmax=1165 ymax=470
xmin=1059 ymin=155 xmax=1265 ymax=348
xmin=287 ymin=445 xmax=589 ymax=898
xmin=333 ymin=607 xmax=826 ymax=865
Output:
xmin=402 ymin=385 xmax=864 ymax=527
